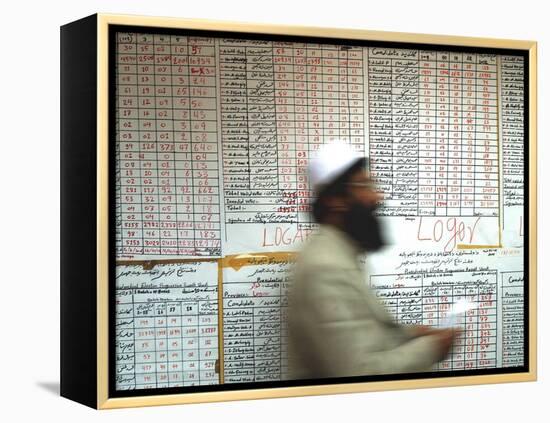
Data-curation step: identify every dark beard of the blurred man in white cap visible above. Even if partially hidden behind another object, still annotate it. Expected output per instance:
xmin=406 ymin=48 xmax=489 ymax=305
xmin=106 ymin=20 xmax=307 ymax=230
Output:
xmin=344 ymin=202 xmax=385 ymax=251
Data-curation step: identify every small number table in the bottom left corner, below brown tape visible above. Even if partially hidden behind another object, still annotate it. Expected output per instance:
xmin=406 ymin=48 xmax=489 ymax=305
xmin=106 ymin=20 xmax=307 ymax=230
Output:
xmin=116 ymin=290 xmax=219 ymax=390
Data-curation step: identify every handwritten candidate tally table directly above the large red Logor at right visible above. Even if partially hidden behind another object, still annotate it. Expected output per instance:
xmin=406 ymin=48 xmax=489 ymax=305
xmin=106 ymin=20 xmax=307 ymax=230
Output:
xmin=368 ymin=48 xmax=499 ymax=216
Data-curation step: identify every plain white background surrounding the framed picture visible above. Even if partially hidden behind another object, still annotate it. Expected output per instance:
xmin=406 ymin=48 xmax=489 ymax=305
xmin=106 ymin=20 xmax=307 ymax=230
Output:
xmin=0 ymin=0 xmax=550 ymax=423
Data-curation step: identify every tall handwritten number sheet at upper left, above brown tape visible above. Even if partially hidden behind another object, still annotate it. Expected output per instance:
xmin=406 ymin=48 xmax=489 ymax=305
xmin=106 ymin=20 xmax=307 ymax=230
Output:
xmin=116 ymin=33 xmax=221 ymax=256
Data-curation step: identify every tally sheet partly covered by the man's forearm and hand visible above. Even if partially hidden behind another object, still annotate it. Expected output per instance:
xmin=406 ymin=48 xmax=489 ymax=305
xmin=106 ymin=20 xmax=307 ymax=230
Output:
xmin=371 ymin=272 xmax=497 ymax=370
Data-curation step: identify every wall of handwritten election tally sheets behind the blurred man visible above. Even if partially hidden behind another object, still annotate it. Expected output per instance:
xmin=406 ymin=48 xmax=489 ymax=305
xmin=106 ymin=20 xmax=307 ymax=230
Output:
xmin=114 ymin=32 xmax=525 ymax=390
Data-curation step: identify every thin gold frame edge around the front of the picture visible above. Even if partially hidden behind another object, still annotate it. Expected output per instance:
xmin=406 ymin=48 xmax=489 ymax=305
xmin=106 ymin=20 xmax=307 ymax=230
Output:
xmin=97 ymin=14 xmax=537 ymax=409
